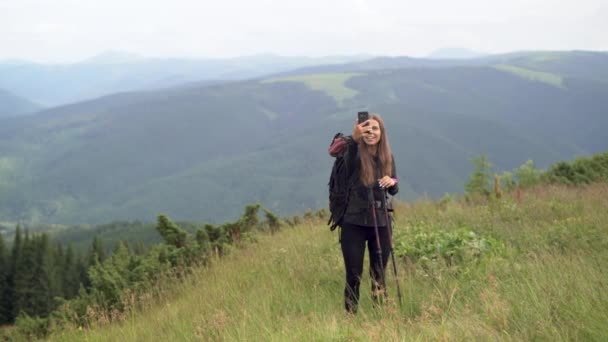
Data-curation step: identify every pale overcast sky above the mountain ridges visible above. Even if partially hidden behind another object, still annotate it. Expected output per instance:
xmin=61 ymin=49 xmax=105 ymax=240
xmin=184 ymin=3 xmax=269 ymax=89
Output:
xmin=0 ymin=0 xmax=608 ymax=62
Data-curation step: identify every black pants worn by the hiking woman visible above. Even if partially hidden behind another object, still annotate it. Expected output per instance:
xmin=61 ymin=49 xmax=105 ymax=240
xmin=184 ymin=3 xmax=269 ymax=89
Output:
xmin=340 ymin=223 xmax=391 ymax=313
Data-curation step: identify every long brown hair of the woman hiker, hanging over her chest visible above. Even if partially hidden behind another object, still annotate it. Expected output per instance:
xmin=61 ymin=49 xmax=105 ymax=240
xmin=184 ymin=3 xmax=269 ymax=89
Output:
xmin=358 ymin=114 xmax=393 ymax=186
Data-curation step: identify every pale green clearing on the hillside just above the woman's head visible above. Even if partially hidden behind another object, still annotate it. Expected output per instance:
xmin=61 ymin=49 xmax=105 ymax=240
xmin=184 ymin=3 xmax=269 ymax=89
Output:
xmin=263 ymin=73 xmax=359 ymax=105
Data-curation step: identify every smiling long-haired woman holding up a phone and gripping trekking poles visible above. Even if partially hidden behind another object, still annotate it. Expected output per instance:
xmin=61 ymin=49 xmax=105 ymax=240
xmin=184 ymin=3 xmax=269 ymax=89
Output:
xmin=329 ymin=114 xmax=399 ymax=313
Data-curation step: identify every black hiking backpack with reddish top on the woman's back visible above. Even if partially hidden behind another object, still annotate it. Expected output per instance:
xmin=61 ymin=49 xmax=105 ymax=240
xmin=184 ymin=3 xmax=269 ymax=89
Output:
xmin=327 ymin=133 xmax=352 ymax=231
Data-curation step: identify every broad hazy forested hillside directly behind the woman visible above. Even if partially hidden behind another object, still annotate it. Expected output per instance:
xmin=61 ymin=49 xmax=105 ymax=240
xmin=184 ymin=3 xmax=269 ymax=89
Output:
xmin=0 ymin=52 xmax=608 ymax=223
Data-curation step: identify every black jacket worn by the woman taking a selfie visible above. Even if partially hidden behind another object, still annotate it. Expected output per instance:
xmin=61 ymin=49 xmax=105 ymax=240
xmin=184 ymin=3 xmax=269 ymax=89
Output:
xmin=343 ymin=139 xmax=399 ymax=227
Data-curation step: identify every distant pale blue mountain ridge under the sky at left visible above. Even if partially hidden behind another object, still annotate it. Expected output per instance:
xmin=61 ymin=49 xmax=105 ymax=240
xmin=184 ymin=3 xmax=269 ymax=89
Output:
xmin=0 ymin=51 xmax=368 ymax=107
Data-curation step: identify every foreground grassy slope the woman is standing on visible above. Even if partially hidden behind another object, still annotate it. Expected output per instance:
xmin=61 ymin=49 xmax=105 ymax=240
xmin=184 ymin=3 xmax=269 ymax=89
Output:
xmin=54 ymin=184 xmax=608 ymax=341
